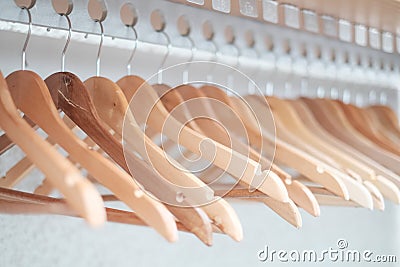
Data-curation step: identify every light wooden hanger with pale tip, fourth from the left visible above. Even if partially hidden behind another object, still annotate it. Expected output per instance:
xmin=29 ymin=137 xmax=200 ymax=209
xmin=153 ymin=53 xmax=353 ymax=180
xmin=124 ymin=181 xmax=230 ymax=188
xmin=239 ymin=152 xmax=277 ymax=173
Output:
xmin=76 ymin=19 xmax=243 ymax=241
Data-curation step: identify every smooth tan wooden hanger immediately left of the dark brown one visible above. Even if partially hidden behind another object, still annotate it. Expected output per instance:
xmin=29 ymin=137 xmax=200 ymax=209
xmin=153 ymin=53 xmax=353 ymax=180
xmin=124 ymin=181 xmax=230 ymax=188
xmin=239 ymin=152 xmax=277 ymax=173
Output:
xmin=6 ymin=7 xmax=181 ymax=242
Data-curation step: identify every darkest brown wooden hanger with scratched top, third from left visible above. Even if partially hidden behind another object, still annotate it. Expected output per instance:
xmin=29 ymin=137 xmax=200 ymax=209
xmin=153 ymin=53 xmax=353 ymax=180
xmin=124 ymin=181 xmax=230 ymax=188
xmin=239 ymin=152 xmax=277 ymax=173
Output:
xmin=40 ymin=9 xmax=219 ymax=245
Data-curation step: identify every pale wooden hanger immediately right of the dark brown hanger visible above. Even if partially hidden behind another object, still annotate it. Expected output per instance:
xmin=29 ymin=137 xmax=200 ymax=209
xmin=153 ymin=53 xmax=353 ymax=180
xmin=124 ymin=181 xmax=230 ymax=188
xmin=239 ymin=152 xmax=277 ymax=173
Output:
xmin=81 ymin=16 xmax=243 ymax=241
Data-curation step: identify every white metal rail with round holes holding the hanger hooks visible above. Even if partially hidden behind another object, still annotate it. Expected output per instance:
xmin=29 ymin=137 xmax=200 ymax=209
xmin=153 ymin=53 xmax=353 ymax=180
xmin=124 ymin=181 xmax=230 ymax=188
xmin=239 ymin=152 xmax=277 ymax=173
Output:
xmin=0 ymin=0 xmax=400 ymax=109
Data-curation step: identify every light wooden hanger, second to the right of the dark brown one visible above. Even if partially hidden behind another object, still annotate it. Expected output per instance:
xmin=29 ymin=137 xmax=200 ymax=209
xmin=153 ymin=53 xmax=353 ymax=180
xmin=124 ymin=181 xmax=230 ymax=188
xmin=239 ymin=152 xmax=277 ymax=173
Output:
xmin=117 ymin=29 xmax=289 ymax=201
